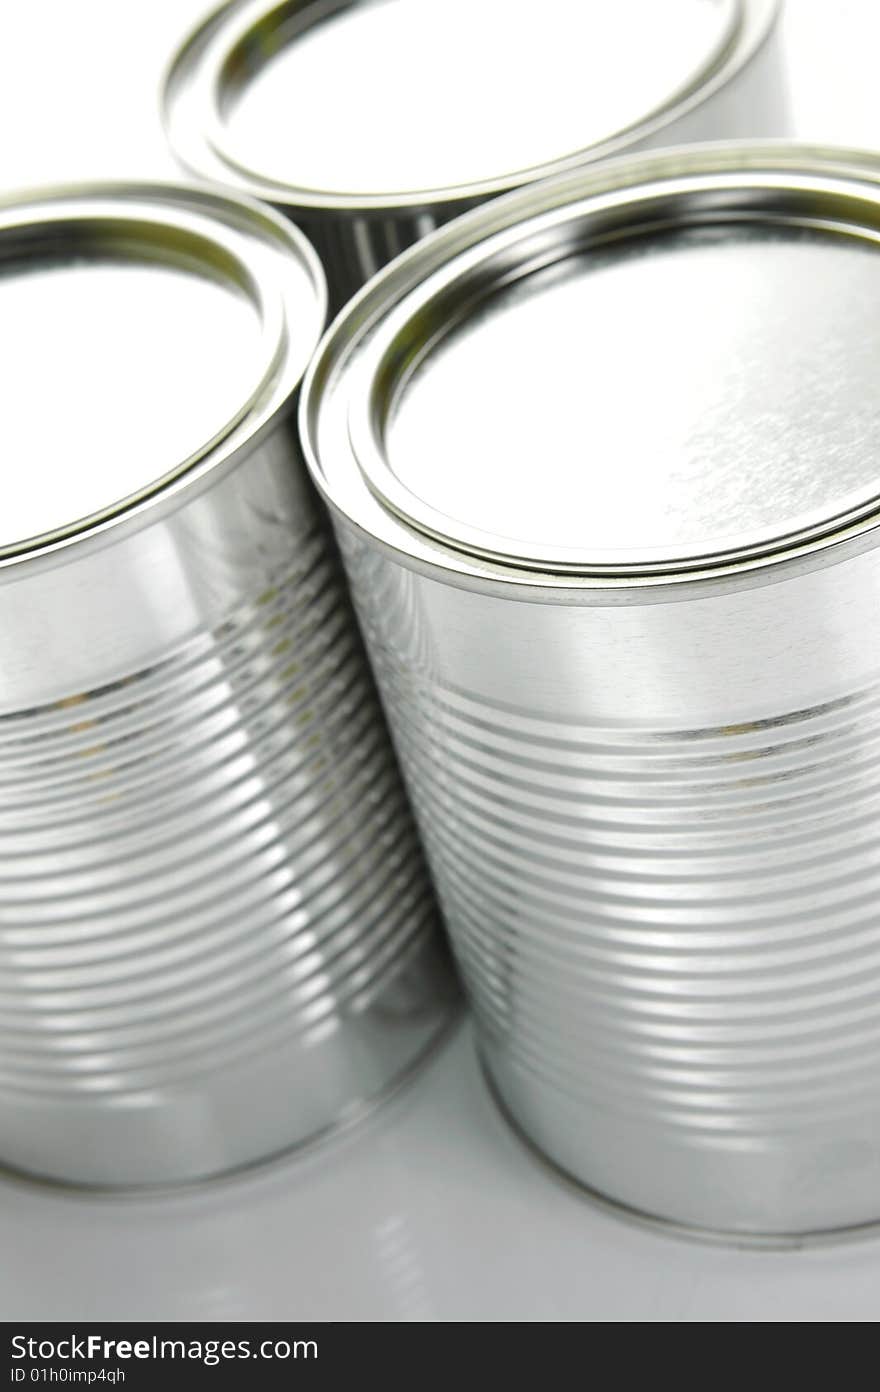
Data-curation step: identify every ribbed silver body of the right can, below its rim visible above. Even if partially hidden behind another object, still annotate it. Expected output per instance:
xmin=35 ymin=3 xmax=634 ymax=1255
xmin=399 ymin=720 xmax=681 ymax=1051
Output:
xmin=338 ymin=535 xmax=880 ymax=1233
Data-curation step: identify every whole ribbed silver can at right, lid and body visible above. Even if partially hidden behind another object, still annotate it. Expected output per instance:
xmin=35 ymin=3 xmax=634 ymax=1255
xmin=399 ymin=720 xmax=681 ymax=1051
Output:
xmin=302 ymin=146 xmax=880 ymax=1235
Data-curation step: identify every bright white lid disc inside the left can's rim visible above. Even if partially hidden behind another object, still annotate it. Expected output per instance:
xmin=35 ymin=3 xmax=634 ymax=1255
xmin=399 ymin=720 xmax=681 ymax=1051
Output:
xmin=0 ymin=262 xmax=259 ymax=547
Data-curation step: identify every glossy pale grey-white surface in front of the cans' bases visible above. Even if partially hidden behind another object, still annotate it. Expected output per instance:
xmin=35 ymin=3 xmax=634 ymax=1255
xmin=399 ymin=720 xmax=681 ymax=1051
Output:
xmin=8 ymin=1029 xmax=880 ymax=1321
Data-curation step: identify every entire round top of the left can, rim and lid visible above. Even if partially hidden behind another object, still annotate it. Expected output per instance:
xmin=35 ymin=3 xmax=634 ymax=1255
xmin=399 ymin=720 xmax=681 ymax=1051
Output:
xmin=0 ymin=185 xmax=326 ymax=561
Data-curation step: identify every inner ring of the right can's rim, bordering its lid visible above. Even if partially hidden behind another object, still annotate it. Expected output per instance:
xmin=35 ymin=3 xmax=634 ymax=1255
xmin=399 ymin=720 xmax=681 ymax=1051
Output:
xmin=348 ymin=173 xmax=880 ymax=575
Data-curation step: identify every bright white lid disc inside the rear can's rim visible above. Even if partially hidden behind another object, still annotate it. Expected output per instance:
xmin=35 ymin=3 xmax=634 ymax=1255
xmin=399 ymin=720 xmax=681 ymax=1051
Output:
xmin=203 ymin=0 xmax=742 ymax=193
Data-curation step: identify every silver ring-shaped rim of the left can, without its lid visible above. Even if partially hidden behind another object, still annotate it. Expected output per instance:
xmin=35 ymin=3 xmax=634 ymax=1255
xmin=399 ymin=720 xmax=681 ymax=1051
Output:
xmin=0 ymin=182 xmax=327 ymax=578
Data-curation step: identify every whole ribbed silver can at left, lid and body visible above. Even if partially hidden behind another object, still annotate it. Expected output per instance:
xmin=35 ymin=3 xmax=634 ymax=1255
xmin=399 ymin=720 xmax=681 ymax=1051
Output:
xmin=0 ymin=185 xmax=459 ymax=1185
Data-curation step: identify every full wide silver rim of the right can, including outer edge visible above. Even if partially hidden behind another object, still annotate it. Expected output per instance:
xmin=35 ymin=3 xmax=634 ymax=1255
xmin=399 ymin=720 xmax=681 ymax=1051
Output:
xmin=301 ymin=141 xmax=880 ymax=603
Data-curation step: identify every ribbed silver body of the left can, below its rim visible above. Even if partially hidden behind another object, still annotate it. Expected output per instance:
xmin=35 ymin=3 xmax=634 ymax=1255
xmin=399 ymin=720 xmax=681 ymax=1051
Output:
xmin=0 ymin=182 xmax=454 ymax=1186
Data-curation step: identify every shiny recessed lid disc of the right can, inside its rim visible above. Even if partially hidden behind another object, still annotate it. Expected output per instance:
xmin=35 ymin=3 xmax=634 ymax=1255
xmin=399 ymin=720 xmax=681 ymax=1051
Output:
xmin=378 ymin=221 xmax=880 ymax=568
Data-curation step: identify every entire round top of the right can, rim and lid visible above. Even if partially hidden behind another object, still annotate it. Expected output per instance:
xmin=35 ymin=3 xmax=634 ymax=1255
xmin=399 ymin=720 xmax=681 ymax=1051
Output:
xmin=302 ymin=145 xmax=880 ymax=598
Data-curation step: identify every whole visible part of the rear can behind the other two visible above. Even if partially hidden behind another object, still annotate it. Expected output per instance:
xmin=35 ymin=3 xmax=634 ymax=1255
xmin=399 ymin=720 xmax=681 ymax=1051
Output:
xmin=164 ymin=0 xmax=787 ymax=305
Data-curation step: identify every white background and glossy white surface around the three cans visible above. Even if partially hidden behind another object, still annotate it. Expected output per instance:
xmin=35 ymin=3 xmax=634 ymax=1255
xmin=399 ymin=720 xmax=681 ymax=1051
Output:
xmin=0 ymin=0 xmax=880 ymax=1321
